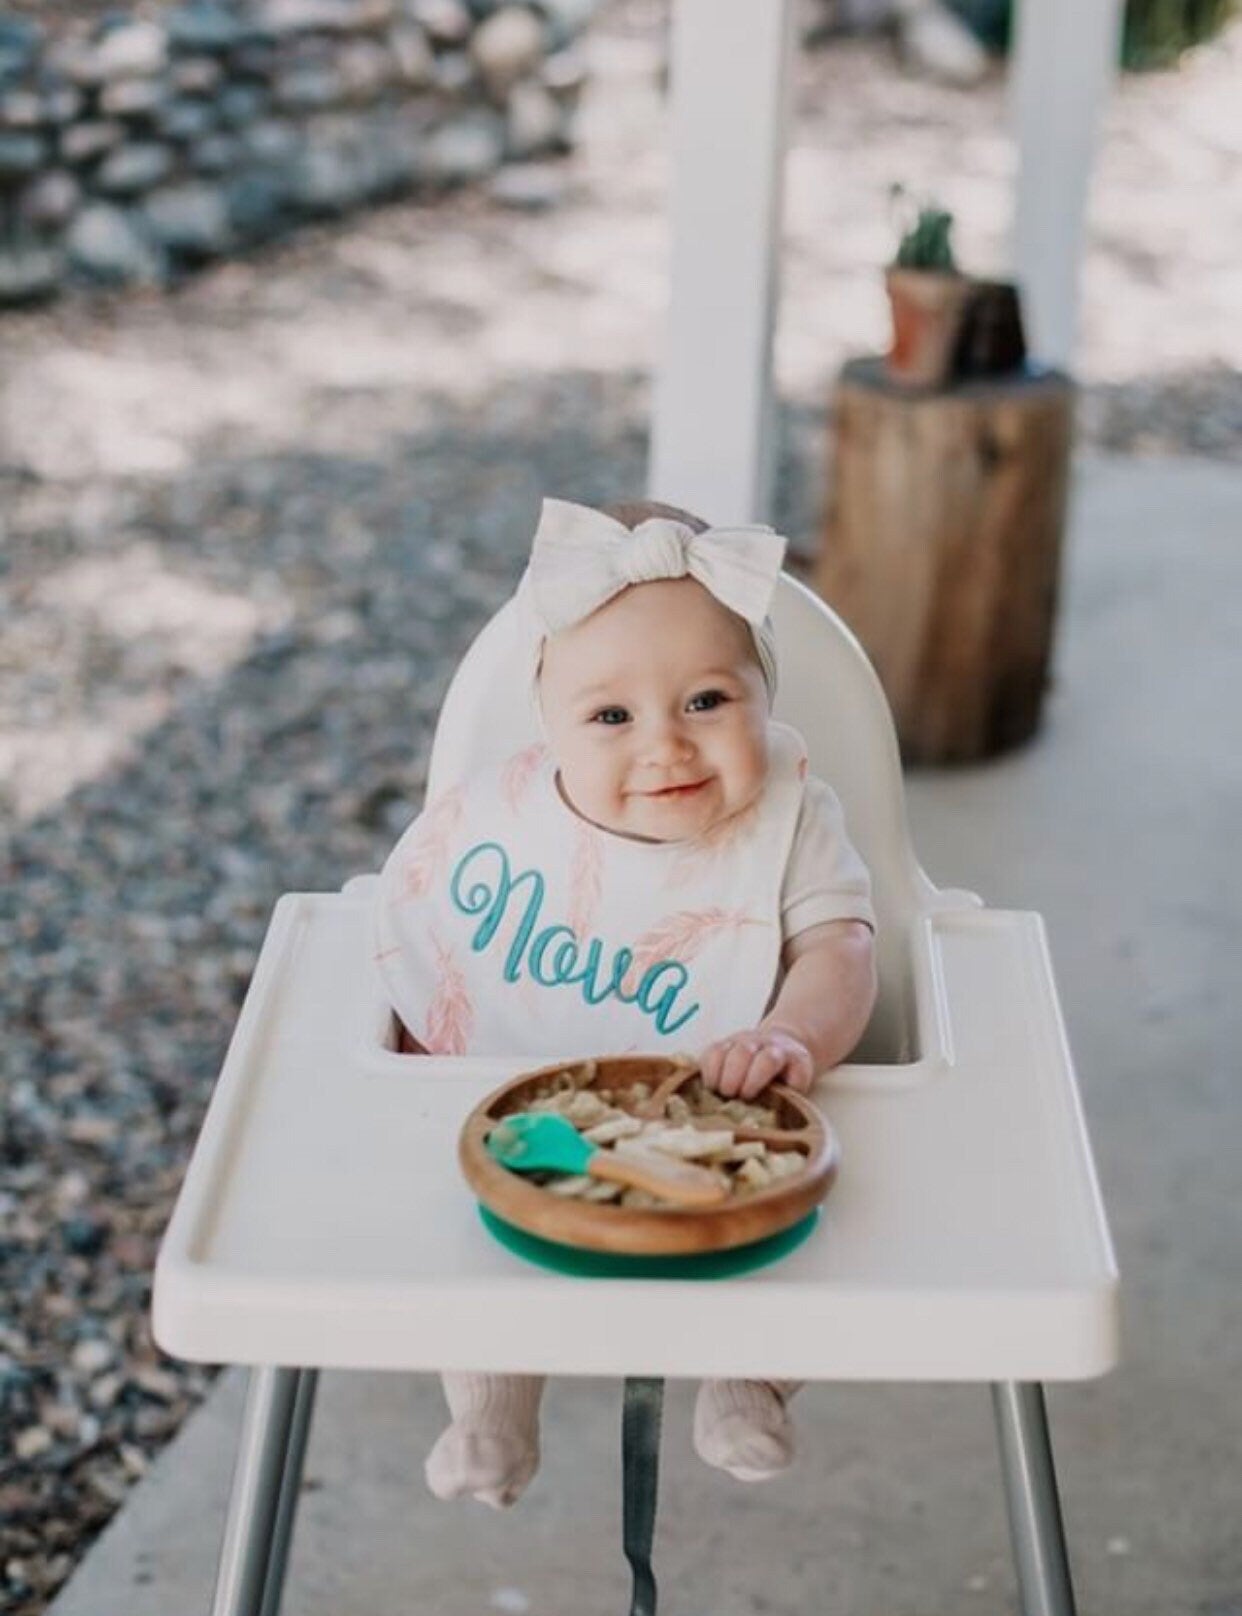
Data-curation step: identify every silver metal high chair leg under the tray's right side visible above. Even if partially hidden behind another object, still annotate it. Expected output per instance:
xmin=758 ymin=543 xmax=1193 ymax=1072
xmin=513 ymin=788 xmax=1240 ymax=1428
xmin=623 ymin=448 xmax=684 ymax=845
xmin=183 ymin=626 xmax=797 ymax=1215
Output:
xmin=992 ymin=1380 xmax=1076 ymax=1616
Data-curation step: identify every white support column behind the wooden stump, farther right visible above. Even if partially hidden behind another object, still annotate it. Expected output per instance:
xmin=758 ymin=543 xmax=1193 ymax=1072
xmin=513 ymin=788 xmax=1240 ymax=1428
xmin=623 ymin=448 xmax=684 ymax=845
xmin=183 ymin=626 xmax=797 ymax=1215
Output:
xmin=1011 ymin=0 xmax=1122 ymax=367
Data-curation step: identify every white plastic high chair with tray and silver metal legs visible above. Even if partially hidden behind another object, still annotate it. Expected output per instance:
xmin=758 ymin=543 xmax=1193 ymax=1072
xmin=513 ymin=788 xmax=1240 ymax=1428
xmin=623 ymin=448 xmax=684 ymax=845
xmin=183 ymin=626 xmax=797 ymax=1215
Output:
xmin=155 ymin=579 xmax=1118 ymax=1616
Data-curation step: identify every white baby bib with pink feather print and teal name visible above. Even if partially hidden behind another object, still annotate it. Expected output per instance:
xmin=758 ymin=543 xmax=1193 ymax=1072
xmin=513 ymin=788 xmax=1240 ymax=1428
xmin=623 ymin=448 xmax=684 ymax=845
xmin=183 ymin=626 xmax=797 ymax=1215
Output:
xmin=375 ymin=724 xmax=806 ymax=1060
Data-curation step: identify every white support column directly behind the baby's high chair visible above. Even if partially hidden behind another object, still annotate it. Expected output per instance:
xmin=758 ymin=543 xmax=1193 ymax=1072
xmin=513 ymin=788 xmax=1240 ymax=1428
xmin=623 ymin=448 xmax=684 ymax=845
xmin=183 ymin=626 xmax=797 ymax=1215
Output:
xmin=648 ymin=0 xmax=793 ymax=522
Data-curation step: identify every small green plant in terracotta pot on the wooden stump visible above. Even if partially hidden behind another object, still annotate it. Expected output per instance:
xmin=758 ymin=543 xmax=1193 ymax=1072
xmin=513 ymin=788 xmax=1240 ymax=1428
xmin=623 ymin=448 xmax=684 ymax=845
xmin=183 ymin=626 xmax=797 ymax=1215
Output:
xmin=885 ymin=186 xmax=971 ymax=388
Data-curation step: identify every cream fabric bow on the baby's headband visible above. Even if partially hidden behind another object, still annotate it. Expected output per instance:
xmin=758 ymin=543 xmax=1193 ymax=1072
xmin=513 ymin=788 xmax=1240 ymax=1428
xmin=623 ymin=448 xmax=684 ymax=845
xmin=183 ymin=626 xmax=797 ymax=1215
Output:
xmin=527 ymin=499 xmax=785 ymax=633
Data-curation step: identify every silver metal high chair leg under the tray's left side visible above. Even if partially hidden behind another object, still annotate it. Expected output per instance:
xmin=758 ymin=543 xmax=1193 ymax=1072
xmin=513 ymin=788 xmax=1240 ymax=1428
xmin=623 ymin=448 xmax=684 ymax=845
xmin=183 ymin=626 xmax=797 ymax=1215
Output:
xmin=212 ymin=1364 xmax=315 ymax=1616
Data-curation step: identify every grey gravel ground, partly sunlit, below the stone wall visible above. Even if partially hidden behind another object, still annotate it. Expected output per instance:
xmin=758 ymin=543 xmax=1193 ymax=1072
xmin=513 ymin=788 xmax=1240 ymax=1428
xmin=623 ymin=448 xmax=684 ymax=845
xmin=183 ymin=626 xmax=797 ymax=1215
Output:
xmin=0 ymin=0 xmax=1242 ymax=1616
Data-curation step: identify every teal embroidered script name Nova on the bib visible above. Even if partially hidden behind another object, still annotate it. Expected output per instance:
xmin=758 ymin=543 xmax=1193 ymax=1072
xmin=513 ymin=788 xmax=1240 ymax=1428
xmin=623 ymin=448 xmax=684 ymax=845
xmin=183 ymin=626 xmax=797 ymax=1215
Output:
xmin=449 ymin=842 xmax=701 ymax=1034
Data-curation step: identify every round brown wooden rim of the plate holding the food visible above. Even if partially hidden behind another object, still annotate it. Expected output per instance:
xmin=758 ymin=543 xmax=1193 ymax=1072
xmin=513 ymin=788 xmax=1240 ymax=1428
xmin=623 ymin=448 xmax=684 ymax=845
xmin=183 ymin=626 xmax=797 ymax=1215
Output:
xmin=459 ymin=1055 xmax=840 ymax=1256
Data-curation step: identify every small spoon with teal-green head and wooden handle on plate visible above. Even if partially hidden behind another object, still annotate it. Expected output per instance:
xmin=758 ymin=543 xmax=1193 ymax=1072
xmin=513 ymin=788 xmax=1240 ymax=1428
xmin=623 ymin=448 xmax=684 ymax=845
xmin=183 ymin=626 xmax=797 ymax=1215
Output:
xmin=486 ymin=1112 xmax=728 ymax=1207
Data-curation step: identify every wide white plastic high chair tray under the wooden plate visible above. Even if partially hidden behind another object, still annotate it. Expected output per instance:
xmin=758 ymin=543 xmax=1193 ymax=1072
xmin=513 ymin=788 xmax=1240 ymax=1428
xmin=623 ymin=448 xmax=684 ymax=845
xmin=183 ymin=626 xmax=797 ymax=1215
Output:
xmin=153 ymin=892 xmax=1116 ymax=1380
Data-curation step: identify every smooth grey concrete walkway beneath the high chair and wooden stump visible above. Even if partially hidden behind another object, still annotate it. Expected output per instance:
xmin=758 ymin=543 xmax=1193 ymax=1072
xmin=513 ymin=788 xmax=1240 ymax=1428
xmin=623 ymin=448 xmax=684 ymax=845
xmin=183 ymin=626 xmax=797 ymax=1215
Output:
xmin=52 ymin=461 xmax=1242 ymax=1616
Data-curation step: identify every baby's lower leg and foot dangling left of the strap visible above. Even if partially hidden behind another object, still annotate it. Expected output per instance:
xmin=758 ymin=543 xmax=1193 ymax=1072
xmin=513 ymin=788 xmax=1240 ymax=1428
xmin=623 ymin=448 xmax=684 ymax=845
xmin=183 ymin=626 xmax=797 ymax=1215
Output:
xmin=426 ymin=1372 xmax=543 ymax=1509
